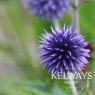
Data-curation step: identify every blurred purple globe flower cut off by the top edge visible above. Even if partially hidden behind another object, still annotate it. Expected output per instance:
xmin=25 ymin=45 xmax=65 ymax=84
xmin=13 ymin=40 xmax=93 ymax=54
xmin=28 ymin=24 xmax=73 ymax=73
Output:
xmin=23 ymin=0 xmax=70 ymax=20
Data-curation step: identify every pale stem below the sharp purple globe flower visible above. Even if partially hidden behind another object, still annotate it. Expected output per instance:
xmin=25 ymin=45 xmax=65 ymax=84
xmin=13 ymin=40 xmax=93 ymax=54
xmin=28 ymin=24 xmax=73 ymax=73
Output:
xmin=68 ymin=73 xmax=78 ymax=95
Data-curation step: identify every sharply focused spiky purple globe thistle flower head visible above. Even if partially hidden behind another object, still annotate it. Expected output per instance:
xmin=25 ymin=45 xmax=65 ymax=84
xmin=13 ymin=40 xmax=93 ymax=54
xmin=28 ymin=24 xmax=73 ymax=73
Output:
xmin=39 ymin=26 xmax=90 ymax=74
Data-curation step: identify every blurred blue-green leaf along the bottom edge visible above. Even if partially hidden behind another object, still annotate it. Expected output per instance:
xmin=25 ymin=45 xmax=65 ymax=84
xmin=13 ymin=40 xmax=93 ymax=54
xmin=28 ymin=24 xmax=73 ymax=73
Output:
xmin=16 ymin=81 xmax=67 ymax=95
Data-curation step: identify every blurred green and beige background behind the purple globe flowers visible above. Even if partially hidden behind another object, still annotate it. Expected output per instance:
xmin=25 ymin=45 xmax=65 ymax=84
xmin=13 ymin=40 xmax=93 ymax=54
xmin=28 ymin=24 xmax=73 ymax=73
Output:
xmin=0 ymin=0 xmax=95 ymax=95
